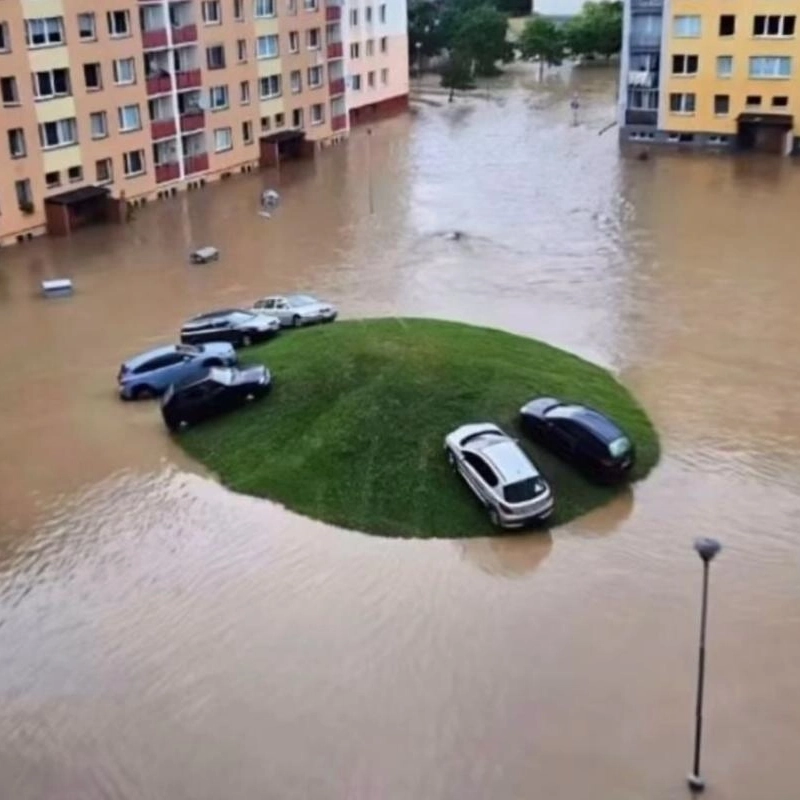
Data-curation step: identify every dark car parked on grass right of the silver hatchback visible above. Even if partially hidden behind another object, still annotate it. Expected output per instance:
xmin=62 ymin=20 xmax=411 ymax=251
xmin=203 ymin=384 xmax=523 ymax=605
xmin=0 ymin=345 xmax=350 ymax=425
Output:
xmin=520 ymin=397 xmax=636 ymax=483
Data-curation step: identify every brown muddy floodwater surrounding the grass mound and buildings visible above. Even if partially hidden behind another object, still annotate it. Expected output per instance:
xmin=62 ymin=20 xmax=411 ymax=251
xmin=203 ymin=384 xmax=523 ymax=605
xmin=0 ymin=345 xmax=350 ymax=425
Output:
xmin=0 ymin=64 xmax=800 ymax=800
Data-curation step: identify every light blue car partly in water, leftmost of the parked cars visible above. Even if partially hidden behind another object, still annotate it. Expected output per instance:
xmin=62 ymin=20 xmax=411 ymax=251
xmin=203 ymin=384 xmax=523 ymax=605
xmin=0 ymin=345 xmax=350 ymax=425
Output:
xmin=117 ymin=342 xmax=237 ymax=400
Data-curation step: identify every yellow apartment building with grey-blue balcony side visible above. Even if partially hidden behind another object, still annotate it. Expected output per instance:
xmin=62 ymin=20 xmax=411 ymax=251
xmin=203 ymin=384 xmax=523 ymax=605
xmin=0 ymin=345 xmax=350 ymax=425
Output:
xmin=618 ymin=0 xmax=800 ymax=154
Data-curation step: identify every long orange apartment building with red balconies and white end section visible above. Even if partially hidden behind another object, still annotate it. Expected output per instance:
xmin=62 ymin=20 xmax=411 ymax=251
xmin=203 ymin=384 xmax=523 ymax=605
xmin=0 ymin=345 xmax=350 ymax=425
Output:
xmin=0 ymin=0 xmax=408 ymax=244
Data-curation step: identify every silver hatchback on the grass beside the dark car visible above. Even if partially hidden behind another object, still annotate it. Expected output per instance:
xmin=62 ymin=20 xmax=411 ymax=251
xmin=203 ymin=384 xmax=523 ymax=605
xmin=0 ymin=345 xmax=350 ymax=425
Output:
xmin=445 ymin=422 xmax=554 ymax=528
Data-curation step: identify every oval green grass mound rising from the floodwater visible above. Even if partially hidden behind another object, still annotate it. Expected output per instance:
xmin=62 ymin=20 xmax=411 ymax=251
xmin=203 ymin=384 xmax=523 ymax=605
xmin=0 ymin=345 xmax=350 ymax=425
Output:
xmin=179 ymin=319 xmax=659 ymax=538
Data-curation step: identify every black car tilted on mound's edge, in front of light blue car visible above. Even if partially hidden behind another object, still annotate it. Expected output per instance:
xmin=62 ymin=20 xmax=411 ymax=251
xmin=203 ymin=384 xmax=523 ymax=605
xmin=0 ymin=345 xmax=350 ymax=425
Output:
xmin=161 ymin=366 xmax=272 ymax=431
